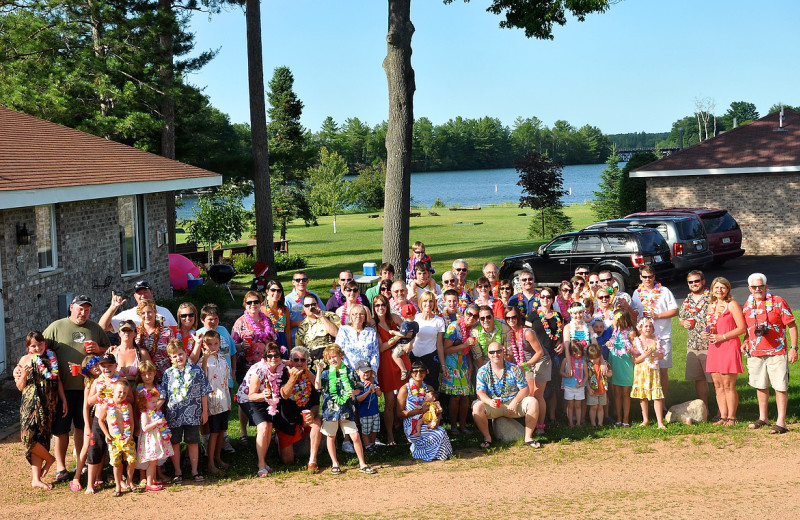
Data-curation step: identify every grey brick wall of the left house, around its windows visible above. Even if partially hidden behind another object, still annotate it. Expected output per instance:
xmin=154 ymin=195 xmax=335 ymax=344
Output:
xmin=0 ymin=193 xmax=169 ymax=366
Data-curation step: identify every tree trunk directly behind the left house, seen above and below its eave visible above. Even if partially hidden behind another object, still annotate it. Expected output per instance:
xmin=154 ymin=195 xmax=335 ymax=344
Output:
xmin=158 ymin=0 xmax=177 ymax=253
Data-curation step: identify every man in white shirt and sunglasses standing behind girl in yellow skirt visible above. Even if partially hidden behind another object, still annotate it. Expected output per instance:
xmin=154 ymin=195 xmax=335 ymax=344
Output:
xmin=631 ymin=265 xmax=678 ymax=394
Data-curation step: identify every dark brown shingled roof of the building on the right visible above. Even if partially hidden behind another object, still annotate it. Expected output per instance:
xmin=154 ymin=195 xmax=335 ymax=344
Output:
xmin=631 ymin=109 xmax=800 ymax=177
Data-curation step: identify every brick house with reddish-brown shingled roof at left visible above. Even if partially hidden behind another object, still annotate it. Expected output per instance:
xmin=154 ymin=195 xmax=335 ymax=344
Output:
xmin=0 ymin=107 xmax=222 ymax=375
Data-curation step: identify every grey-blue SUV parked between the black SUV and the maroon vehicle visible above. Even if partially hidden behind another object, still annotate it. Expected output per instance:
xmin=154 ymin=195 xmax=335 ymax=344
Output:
xmin=586 ymin=215 xmax=714 ymax=273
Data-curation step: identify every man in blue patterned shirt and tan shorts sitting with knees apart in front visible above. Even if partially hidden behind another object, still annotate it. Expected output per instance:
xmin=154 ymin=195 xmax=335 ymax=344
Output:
xmin=472 ymin=342 xmax=541 ymax=449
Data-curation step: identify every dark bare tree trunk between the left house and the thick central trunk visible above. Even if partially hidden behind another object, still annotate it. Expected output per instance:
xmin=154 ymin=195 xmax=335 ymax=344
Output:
xmin=245 ymin=0 xmax=277 ymax=275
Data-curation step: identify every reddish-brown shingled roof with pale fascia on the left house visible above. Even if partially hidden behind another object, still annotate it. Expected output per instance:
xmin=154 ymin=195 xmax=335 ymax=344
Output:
xmin=0 ymin=106 xmax=222 ymax=208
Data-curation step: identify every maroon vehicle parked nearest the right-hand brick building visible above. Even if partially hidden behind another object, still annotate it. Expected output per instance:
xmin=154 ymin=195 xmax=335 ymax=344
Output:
xmin=625 ymin=208 xmax=745 ymax=266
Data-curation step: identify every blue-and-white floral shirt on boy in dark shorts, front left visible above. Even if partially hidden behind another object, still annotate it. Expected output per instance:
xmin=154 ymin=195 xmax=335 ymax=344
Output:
xmin=161 ymin=365 xmax=212 ymax=428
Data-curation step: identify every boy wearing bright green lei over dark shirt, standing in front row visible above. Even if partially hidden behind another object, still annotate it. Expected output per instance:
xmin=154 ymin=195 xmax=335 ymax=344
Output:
xmin=314 ymin=343 xmax=376 ymax=475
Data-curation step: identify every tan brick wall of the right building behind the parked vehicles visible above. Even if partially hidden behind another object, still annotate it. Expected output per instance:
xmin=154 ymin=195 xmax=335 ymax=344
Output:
xmin=647 ymin=172 xmax=800 ymax=255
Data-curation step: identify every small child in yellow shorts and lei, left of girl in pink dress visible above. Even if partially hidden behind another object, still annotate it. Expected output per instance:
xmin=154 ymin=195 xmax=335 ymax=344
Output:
xmin=97 ymin=380 xmax=138 ymax=497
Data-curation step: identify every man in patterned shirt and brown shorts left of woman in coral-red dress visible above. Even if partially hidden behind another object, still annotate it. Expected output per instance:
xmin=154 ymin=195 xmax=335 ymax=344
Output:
xmin=678 ymin=270 xmax=711 ymax=407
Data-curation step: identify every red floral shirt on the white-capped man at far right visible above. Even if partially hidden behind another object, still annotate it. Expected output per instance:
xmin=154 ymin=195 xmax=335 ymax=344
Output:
xmin=742 ymin=292 xmax=794 ymax=357
